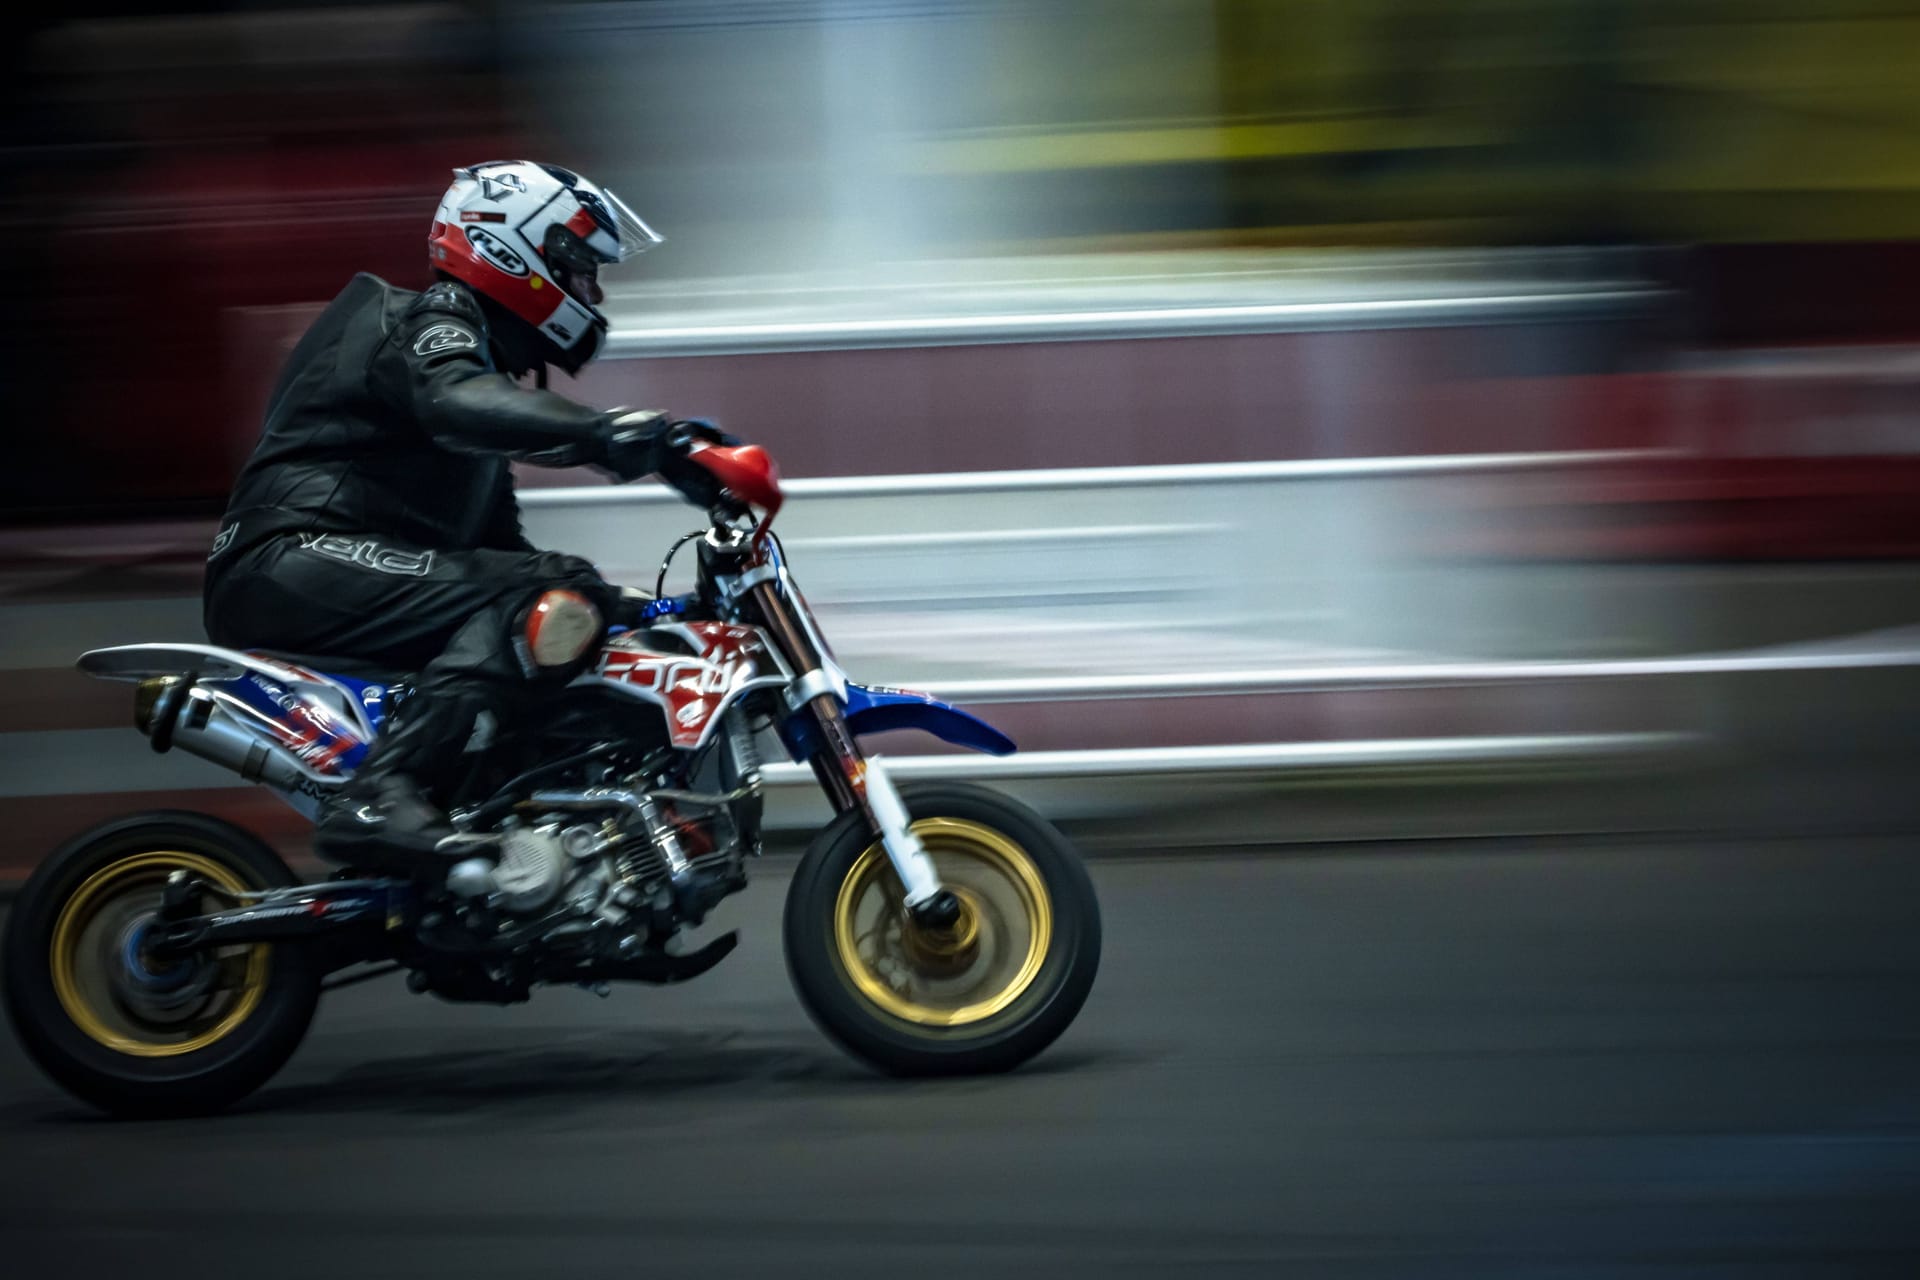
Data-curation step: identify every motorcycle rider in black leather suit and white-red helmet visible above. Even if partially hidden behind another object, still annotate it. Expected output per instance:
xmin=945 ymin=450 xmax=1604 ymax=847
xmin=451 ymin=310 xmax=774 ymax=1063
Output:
xmin=205 ymin=161 xmax=716 ymax=875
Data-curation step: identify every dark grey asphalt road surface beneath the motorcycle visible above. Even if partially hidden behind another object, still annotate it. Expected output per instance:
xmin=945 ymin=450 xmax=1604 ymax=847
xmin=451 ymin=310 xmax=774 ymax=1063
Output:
xmin=0 ymin=839 xmax=1920 ymax=1280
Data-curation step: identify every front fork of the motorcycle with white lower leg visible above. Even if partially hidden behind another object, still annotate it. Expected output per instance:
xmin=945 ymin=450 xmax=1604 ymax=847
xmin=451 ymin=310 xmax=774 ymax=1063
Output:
xmin=749 ymin=580 xmax=960 ymax=929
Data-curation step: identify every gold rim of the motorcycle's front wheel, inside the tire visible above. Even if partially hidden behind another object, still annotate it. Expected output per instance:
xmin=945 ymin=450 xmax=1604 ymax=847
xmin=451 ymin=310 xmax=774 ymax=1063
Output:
xmin=833 ymin=818 xmax=1054 ymax=1027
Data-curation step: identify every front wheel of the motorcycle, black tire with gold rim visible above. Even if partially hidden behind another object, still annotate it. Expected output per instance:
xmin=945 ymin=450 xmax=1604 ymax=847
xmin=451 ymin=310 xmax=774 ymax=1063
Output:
xmin=785 ymin=785 xmax=1100 ymax=1075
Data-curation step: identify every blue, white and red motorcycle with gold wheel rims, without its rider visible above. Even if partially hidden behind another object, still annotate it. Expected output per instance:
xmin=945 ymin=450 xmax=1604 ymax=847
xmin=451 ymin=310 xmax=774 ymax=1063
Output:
xmin=6 ymin=436 xmax=1100 ymax=1115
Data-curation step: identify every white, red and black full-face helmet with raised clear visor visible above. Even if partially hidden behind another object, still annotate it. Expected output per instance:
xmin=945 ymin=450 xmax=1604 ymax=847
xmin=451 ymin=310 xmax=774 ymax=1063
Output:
xmin=426 ymin=159 xmax=660 ymax=374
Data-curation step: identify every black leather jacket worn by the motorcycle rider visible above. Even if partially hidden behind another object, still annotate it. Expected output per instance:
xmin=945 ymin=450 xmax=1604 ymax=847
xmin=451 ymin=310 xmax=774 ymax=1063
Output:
xmin=209 ymin=274 xmax=611 ymax=572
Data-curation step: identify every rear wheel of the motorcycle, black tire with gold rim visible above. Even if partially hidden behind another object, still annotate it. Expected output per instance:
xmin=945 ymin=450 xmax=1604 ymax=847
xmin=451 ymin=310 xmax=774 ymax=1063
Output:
xmin=4 ymin=812 xmax=321 ymax=1117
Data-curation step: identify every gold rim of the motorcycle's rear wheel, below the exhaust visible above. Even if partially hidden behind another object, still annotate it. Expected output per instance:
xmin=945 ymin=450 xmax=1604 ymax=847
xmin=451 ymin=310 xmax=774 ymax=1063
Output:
xmin=48 ymin=850 xmax=271 ymax=1057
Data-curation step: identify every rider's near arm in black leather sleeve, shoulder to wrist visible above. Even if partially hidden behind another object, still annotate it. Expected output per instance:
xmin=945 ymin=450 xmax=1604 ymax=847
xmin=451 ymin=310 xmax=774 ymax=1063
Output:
xmin=369 ymin=284 xmax=611 ymax=466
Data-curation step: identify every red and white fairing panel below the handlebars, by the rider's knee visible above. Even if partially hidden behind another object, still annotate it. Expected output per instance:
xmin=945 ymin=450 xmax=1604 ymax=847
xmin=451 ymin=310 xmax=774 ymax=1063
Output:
xmin=582 ymin=622 xmax=793 ymax=750
